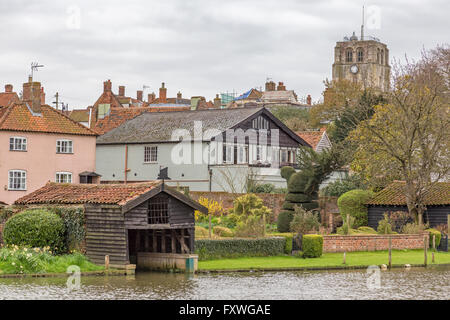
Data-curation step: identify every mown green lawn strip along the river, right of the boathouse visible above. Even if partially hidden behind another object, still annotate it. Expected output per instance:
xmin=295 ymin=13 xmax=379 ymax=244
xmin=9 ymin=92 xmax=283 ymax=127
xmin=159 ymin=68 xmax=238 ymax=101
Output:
xmin=198 ymin=250 xmax=450 ymax=270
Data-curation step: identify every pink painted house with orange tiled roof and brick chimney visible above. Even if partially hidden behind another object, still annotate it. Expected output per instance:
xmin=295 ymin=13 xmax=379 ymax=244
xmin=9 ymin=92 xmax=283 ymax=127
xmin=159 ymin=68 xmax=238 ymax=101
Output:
xmin=0 ymin=78 xmax=99 ymax=204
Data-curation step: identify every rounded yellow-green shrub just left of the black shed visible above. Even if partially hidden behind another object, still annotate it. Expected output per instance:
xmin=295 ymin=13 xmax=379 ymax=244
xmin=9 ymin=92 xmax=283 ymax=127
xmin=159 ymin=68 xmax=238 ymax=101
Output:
xmin=338 ymin=189 xmax=373 ymax=227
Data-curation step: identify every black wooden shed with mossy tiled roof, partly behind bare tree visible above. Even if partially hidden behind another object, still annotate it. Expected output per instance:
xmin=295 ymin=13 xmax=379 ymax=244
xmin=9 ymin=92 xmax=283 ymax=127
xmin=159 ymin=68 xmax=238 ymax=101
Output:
xmin=367 ymin=181 xmax=450 ymax=229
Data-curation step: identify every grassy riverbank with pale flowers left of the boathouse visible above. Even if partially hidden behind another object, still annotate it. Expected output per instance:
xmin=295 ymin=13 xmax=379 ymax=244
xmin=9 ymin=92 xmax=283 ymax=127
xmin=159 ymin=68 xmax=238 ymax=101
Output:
xmin=0 ymin=247 xmax=104 ymax=275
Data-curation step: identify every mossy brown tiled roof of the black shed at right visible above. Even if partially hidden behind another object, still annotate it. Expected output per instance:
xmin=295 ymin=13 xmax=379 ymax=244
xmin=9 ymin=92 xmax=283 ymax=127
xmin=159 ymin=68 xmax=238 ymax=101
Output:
xmin=367 ymin=181 xmax=450 ymax=206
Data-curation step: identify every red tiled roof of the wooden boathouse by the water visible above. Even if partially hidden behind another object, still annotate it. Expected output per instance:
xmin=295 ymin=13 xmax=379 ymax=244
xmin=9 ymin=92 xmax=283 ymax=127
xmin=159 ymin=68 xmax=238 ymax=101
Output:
xmin=15 ymin=181 xmax=162 ymax=205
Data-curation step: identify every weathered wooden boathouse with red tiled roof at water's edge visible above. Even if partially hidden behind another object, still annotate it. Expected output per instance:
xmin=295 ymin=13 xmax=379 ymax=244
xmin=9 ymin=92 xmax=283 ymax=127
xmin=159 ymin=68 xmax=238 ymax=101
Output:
xmin=15 ymin=181 xmax=207 ymax=269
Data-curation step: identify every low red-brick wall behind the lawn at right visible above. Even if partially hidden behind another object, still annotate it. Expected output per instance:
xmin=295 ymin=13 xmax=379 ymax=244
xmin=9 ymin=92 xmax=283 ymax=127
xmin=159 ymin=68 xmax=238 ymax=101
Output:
xmin=323 ymin=233 xmax=428 ymax=252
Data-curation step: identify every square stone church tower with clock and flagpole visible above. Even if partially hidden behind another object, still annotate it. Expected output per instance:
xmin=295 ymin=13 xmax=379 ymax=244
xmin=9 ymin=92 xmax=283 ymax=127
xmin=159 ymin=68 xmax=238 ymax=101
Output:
xmin=332 ymin=9 xmax=391 ymax=91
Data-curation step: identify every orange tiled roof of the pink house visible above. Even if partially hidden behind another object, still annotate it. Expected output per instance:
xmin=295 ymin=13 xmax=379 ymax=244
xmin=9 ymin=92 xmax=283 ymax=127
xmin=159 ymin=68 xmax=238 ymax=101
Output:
xmin=0 ymin=103 xmax=96 ymax=136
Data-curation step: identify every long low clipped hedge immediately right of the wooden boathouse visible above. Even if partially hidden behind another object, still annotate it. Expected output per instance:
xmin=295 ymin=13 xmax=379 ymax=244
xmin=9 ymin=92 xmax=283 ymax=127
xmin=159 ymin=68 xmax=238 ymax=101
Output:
xmin=195 ymin=237 xmax=286 ymax=260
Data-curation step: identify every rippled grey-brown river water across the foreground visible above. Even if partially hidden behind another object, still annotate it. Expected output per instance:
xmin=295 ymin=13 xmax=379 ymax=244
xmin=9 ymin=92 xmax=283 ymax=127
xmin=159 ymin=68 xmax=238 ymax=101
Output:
xmin=0 ymin=267 xmax=450 ymax=300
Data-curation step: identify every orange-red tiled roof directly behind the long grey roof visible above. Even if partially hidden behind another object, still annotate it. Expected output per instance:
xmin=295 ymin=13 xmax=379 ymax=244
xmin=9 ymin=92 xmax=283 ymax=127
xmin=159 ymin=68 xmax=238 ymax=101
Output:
xmin=93 ymin=106 xmax=191 ymax=135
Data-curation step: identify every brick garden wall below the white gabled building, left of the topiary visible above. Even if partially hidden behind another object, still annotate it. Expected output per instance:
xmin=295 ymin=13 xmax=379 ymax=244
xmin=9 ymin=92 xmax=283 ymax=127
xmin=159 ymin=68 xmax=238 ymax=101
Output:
xmin=189 ymin=191 xmax=286 ymax=219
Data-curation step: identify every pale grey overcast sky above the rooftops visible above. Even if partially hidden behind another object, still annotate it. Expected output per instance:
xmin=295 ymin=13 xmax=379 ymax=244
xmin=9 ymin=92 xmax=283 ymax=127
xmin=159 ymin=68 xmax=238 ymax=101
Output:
xmin=0 ymin=0 xmax=450 ymax=109
